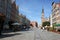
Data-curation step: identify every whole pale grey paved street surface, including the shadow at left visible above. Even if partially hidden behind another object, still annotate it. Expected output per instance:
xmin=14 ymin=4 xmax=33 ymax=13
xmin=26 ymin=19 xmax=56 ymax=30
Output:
xmin=0 ymin=28 xmax=60 ymax=40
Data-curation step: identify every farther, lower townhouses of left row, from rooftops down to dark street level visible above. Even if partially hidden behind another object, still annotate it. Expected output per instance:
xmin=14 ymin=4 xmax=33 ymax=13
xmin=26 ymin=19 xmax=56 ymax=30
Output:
xmin=19 ymin=14 xmax=30 ymax=30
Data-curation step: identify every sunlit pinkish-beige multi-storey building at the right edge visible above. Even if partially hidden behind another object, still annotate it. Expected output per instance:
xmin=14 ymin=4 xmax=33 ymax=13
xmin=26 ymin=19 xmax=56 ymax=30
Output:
xmin=52 ymin=2 xmax=60 ymax=25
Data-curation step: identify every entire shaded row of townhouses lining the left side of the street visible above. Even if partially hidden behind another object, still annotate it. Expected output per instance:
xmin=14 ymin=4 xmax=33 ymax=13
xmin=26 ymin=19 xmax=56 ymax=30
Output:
xmin=0 ymin=0 xmax=30 ymax=28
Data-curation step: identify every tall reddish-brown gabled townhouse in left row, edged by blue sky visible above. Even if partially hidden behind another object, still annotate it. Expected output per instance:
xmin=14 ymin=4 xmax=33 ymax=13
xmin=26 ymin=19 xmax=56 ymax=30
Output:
xmin=11 ymin=1 xmax=19 ymax=22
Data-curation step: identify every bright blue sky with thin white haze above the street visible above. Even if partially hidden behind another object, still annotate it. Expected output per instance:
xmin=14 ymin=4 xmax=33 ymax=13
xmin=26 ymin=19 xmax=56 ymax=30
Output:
xmin=16 ymin=0 xmax=60 ymax=24
